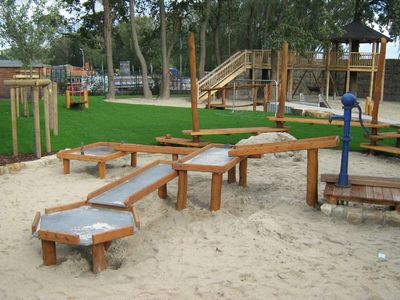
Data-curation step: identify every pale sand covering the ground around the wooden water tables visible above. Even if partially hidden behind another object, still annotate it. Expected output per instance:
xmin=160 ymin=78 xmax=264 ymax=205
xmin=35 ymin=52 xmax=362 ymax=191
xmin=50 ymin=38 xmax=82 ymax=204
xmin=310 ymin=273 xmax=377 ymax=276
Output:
xmin=0 ymin=97 xmax=400 ymax=299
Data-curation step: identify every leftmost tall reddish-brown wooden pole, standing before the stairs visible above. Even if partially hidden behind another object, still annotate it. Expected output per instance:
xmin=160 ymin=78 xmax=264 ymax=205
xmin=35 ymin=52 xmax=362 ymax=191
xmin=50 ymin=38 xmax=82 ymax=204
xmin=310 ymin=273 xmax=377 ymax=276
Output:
xmin=188 ymin=32 xmax=200 ymax=142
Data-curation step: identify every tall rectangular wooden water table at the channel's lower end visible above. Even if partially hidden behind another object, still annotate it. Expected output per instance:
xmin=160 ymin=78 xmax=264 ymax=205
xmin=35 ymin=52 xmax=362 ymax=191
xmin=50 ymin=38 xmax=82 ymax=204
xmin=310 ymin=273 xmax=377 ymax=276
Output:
xmin=172 ymin=144 xmax=247 ymax=211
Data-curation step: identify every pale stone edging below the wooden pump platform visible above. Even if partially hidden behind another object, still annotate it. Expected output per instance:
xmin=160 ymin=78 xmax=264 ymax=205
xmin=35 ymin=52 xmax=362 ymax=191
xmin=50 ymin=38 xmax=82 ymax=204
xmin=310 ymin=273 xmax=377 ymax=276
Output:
xmin=321 ymin=203 xmax=400 ymax=226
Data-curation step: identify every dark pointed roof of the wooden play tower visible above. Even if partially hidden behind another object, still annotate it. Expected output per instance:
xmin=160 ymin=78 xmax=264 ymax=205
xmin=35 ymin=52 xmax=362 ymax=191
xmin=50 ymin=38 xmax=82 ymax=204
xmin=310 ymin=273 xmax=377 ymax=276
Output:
xmin=331 ymin=21 xmax=392 ymax=43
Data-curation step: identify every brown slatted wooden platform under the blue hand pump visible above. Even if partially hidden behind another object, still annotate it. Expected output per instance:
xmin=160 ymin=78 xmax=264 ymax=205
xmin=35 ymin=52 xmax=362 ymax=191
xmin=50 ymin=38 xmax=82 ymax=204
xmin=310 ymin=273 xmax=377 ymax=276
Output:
xmin=321 ymin=174 xmax=400 ymax=211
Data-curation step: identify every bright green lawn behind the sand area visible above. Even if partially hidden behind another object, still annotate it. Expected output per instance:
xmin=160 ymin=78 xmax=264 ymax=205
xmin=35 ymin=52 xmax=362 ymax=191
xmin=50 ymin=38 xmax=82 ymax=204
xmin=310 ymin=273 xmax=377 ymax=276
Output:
xmin=0 ymin=96 xmax=391 ymax=155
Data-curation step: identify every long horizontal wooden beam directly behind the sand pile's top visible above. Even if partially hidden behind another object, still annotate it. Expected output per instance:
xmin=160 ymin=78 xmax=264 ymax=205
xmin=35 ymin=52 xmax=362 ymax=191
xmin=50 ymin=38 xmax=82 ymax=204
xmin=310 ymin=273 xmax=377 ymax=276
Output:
xmin=182 ymin=127 xmax=289 ymax=136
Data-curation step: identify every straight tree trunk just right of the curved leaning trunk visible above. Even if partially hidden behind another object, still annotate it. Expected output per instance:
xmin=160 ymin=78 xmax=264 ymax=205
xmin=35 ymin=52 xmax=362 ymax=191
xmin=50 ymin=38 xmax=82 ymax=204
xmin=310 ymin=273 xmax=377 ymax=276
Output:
xmin=159 ymin=0 xmax=170 ymax=99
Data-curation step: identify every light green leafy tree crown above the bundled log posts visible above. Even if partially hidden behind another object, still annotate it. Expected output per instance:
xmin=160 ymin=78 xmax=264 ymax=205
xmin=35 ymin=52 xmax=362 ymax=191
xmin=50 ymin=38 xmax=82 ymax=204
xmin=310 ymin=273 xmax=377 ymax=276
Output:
xmin=0 ymin=0 xmax=64 ymax=72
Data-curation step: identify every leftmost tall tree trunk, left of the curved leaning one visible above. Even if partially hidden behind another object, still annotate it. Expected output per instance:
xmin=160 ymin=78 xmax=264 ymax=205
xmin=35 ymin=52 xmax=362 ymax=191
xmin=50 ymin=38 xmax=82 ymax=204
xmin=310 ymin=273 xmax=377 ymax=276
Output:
xmin=103 ymin=0 xmax=115 ymax=99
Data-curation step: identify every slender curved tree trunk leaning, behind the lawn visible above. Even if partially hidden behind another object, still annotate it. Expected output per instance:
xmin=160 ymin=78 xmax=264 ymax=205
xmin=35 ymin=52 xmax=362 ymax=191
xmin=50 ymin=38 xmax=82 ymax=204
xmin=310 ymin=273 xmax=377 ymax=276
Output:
xmin=129 ymin=0 xmax=153 ymax=99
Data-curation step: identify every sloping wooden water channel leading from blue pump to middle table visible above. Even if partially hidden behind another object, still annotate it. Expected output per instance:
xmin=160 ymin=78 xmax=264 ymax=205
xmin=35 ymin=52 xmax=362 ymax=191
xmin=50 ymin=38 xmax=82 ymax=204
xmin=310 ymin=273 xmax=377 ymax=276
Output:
xmin=229 ymin=136 xmax=339 ymax=156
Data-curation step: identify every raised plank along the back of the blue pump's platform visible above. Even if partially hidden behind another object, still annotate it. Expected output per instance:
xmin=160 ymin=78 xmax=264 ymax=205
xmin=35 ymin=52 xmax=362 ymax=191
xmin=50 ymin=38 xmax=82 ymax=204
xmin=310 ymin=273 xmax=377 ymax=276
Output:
xmin=321 ymin=174 xmax=400 ymax=188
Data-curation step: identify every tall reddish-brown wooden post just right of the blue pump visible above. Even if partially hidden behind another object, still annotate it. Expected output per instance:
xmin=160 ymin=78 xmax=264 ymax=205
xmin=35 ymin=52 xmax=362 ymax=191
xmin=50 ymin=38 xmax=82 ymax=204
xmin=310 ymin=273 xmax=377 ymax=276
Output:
xmin=371 ymin=38 xmax=386 ymax=137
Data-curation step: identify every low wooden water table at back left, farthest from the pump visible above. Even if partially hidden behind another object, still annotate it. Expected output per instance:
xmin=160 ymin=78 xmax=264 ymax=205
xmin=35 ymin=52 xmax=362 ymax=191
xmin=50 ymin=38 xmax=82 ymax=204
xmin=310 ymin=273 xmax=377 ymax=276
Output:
xmin=57 ymin=142 xmax=136 ymax=179
